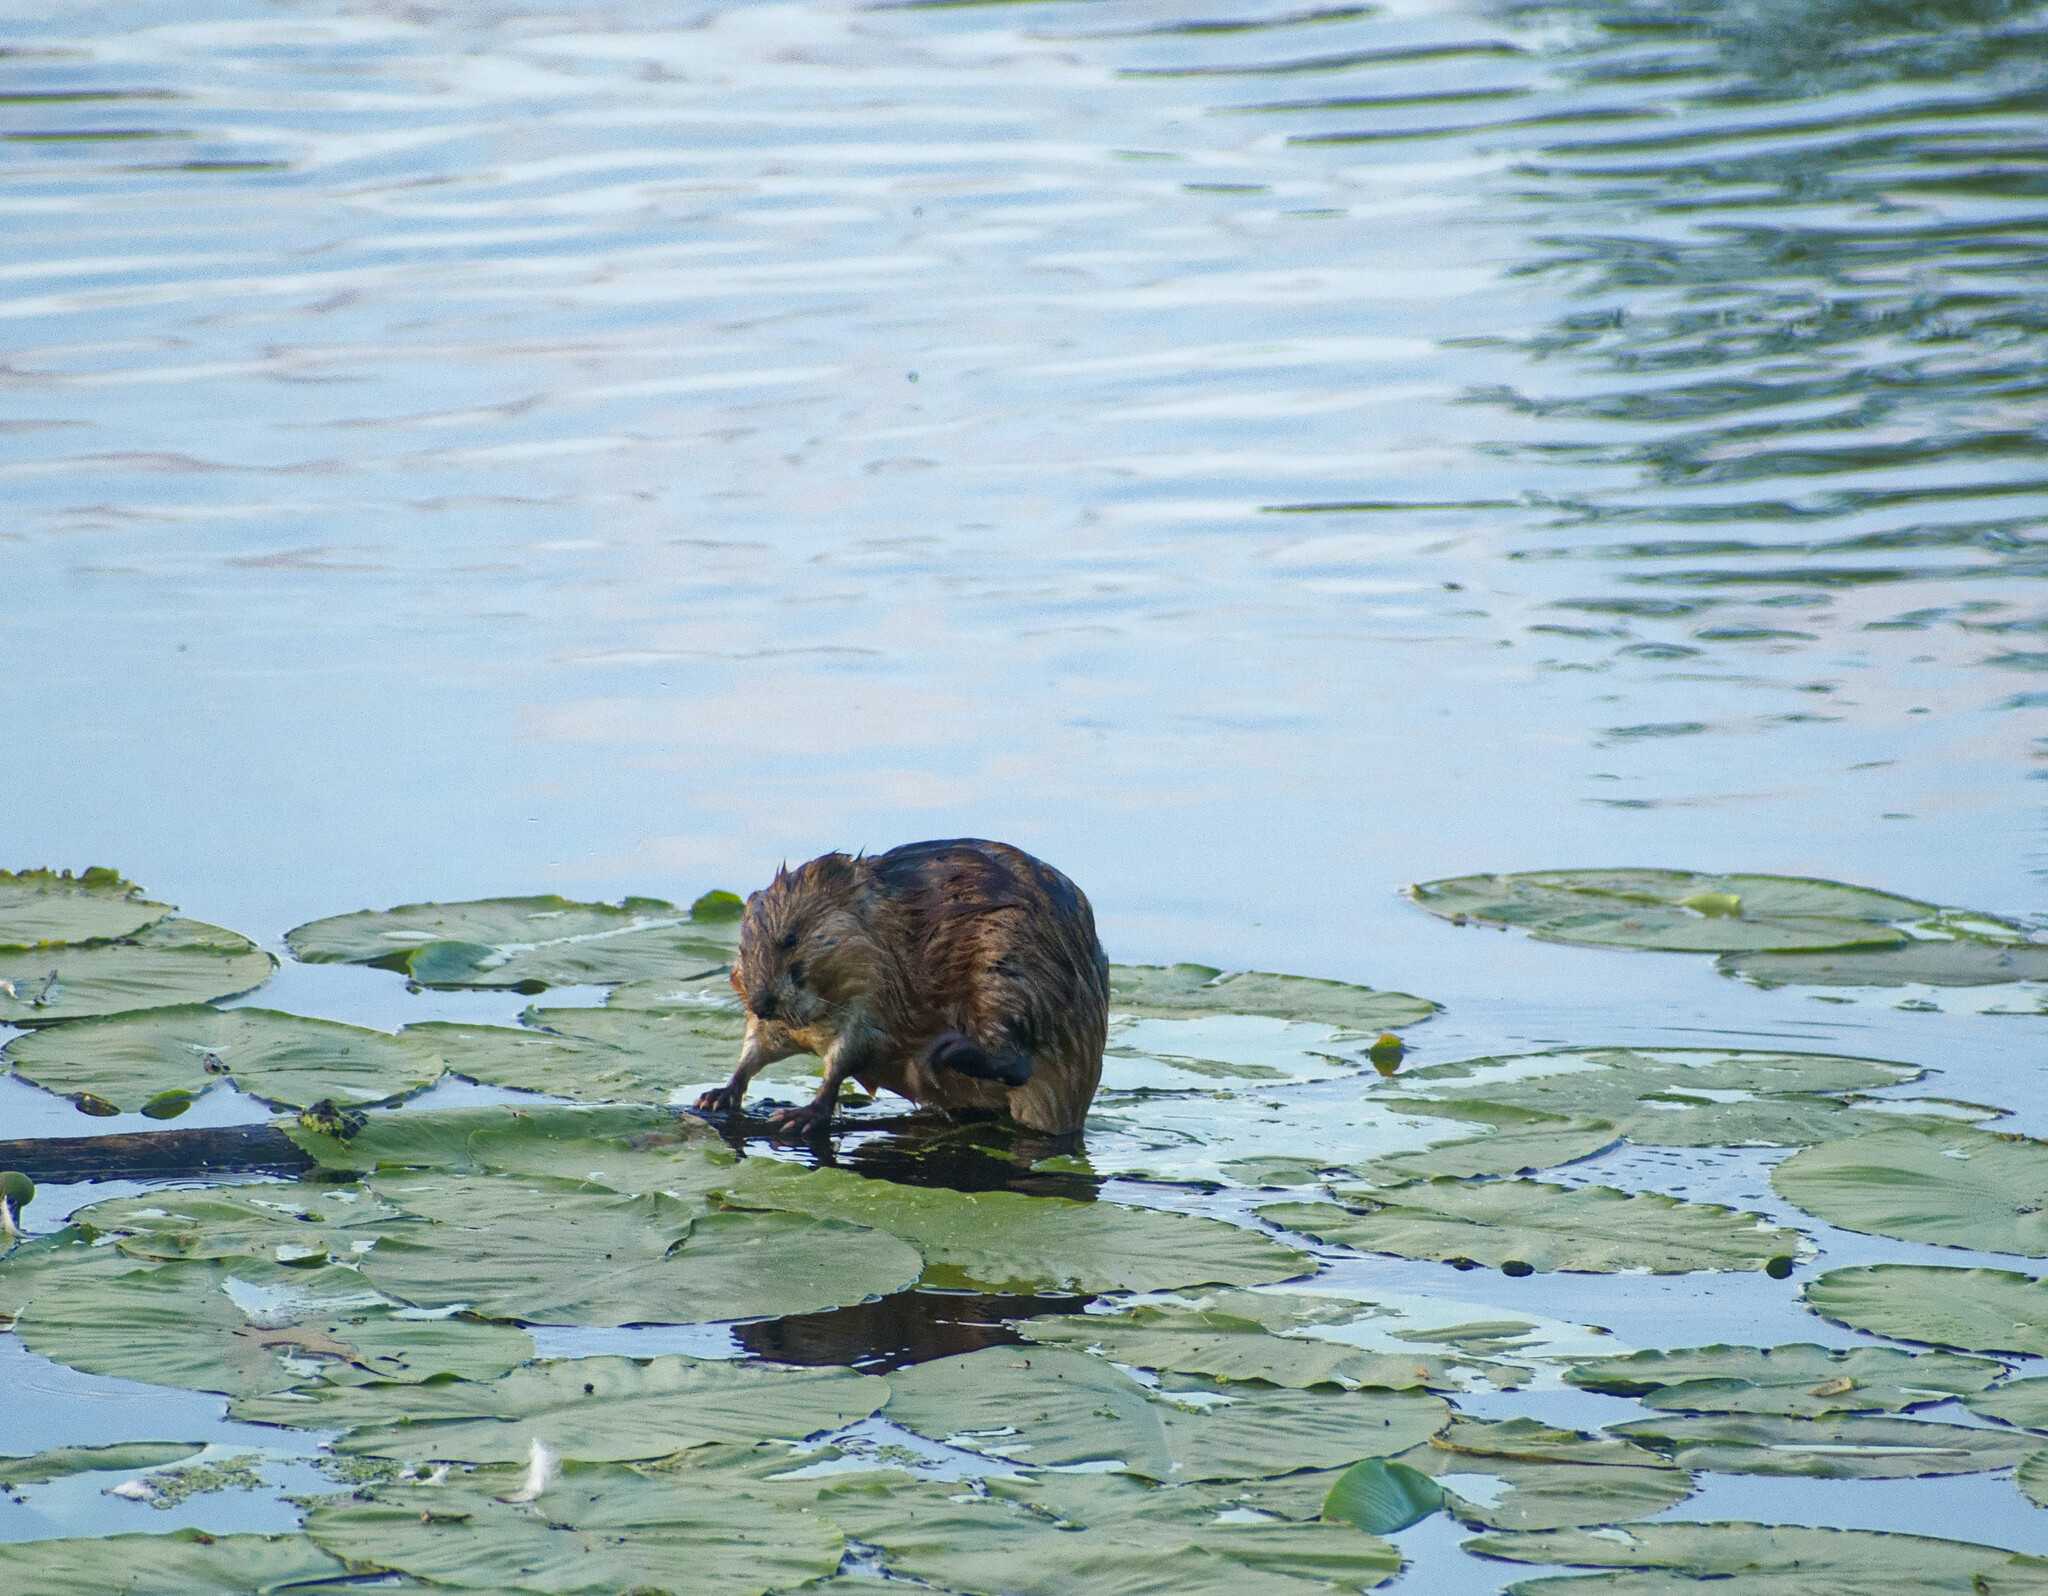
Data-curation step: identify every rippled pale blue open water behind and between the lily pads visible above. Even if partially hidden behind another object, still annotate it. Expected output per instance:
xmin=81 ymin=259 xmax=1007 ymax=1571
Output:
xmin=0 ymin=0 xmax=2048 ymax=1590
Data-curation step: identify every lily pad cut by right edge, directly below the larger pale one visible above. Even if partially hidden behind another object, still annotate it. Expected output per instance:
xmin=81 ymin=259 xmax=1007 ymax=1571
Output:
xmin=1806 ymin=1264 xmax=2048 ymax=1356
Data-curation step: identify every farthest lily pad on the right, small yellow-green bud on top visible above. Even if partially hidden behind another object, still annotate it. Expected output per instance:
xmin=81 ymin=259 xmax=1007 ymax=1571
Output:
xmin=1411 ymin=871 xmax=1939 ymax=953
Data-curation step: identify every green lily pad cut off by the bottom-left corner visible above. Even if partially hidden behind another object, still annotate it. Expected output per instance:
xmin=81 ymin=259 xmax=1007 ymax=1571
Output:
xmin=0 ymin=1530 xmax=348 ymax=1596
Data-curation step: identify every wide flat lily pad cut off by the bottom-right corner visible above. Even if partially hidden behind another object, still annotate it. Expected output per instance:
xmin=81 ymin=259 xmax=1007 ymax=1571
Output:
xmin=1464 ymin=1522 xmax=2048 ymax=1596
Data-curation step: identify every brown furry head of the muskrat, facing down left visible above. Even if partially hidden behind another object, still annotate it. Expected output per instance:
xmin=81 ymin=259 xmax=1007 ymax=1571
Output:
xmin=733 ymin=854 xmax=866 ymax=1031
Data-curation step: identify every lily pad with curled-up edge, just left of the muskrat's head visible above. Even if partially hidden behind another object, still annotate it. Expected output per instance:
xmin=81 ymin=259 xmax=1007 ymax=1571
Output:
xmin=285 ymin=897 xmax=737 ymax=992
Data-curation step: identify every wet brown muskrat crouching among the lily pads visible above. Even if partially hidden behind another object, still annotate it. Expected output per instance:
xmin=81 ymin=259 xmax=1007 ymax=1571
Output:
xmin=696 ymin=838 xmax=1110 ymax=1135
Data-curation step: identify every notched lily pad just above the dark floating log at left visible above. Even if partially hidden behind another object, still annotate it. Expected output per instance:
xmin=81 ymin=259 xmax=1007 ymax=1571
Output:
xmin=0 ymin=1004 xmax=440 ymax=1110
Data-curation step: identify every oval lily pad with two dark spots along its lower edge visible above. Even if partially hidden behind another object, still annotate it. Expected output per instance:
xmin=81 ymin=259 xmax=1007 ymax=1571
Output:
xmin=1257 ymin=1178 xmax=1798 ymax=1274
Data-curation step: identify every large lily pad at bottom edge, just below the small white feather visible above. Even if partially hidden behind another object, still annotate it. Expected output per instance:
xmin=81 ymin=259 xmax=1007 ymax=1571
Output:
xmin=305 ymin=1448 xmax=844 ymax=1596
